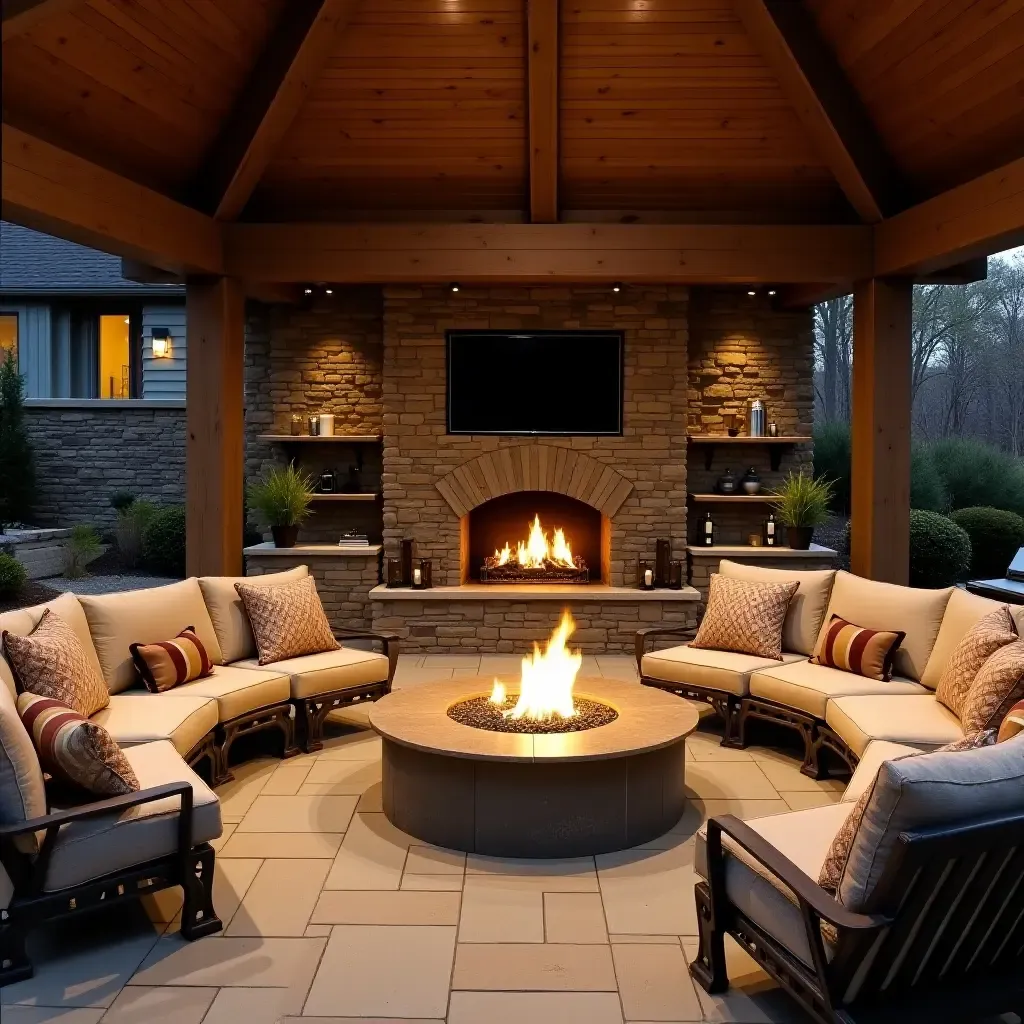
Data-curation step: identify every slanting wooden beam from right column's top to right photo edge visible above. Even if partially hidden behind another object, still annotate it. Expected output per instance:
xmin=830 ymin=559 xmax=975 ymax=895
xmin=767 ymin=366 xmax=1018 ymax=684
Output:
xmin=874 ymin=158 xmax=1024 ymax=276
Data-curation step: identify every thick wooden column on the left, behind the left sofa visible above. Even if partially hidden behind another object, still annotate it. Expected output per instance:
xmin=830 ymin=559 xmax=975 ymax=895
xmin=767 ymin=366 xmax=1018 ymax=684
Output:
xmin=185 ymin=278 xmax=245 ymax=575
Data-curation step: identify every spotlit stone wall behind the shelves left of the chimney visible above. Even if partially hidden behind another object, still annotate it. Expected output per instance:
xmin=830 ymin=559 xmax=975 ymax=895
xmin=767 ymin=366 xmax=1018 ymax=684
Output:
xmin=246 ymin=288 xmax=383 ymax=544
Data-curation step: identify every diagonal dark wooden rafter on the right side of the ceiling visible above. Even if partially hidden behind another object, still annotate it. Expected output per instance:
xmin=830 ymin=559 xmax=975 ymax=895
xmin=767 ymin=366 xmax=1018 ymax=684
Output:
xmin=733 ymin=0 xmax=913 ymax=223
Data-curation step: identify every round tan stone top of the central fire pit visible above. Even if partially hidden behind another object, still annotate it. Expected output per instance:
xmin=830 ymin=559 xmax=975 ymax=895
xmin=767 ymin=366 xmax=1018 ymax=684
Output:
xmin=370 ymin=676 xmax=699 ymax=761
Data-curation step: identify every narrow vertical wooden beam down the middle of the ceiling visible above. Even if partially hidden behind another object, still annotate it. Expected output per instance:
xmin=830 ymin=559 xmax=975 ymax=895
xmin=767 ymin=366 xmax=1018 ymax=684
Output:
xmin=526 ymin=0 xmax=558 ymax=224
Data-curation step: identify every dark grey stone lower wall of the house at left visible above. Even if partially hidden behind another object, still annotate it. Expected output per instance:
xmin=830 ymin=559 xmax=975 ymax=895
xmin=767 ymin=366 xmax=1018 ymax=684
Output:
xmin=25 ymin=399 xmax=185 ymax=530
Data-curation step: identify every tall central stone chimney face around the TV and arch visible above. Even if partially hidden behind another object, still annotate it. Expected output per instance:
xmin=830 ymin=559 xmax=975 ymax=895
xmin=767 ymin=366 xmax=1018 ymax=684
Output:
xmin=383 ymin=286 xmax=688 ymax=586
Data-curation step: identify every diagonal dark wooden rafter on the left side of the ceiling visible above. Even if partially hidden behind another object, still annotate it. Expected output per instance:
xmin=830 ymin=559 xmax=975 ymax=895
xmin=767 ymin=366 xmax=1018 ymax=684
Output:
xmin=193 ymin=0 xmax=356 ymax=220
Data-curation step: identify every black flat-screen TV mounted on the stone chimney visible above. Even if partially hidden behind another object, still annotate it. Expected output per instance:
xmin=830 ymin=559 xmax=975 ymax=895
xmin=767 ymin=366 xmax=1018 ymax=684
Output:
xmin=447 ymin=331 xmax=623 ymax=434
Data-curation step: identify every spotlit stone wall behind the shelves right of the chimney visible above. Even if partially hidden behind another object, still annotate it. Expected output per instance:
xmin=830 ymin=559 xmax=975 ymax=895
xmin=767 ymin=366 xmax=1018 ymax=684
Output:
xmin=687 ymin=288 xmax=814 ymax=544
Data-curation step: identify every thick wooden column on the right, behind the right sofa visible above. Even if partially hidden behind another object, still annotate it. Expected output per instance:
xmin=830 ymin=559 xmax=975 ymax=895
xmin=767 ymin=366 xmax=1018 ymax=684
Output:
xmin=850 ymin=279 xmax=912 ymax=585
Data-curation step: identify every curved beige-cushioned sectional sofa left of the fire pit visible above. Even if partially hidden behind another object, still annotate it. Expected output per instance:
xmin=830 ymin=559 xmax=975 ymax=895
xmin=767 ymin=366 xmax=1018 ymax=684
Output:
xmin=0 ymin=566 xmax=398 ymax=985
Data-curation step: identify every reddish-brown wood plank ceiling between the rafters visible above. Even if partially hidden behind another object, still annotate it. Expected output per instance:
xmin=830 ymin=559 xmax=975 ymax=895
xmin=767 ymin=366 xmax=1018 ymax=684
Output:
xmin=3 ymin=0 xmax=1024 ymax=223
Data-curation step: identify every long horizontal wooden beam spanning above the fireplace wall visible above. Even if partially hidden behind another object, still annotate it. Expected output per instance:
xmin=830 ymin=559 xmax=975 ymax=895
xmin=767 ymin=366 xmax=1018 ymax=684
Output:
xmin=224 ymin=223 xmax=871 ymax=285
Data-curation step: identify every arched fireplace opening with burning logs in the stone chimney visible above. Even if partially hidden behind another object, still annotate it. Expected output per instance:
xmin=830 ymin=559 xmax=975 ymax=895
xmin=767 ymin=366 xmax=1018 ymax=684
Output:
xmin=462 ymin=490 xmax=608 ymax=584
